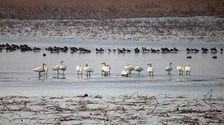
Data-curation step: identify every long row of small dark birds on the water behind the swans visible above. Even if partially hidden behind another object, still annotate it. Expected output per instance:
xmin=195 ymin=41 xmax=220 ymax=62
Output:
xmin=0 ymin=43 xmax=223 ymax=59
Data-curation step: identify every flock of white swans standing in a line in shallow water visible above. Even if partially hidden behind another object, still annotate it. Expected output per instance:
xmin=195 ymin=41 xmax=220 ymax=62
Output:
xmin=33 ymin=61 xmax=191 ymax=77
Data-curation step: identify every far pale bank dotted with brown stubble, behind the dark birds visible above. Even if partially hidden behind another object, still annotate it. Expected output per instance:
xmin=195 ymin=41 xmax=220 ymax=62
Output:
xmin=0 ymin=17 xmax=224 ymax=42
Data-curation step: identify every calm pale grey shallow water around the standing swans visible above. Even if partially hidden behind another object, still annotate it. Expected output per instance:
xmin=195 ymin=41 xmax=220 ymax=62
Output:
xmin=0 ymin=38 xmax=224 ymax=97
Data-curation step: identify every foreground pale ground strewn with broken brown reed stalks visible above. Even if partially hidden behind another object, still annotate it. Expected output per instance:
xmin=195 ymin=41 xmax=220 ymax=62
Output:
xmin=0 ymin=90 xmax=224 ymax=124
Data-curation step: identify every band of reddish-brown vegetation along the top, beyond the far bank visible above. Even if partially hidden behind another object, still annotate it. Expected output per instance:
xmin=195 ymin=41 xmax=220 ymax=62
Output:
xmin=0 ymin=0 xmax=224 ymax=19
